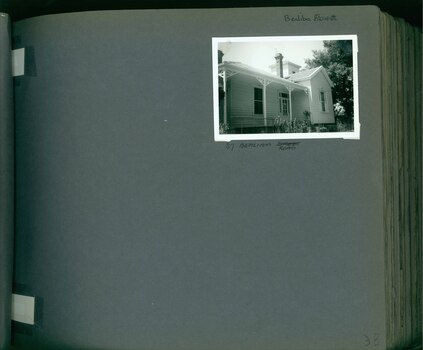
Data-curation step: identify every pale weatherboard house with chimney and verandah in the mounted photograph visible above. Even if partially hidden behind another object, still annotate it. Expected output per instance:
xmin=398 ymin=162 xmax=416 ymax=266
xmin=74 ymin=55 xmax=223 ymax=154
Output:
xmin=218 ymin=53 xmax=335 ymax=133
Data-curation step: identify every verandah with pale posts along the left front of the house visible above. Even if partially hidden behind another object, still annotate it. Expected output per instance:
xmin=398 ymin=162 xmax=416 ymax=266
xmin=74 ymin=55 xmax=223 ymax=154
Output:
xmin=219 ymin=62 xmax=311 ymax=132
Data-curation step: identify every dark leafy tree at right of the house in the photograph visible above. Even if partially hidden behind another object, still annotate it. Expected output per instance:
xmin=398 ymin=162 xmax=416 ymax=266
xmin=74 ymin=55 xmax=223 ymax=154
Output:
xmin=305 ymin=40 xmax=354 ymax=123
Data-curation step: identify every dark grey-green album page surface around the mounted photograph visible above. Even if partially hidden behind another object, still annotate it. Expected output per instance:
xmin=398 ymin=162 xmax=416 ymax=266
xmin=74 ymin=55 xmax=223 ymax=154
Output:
xmin=13 ymin=7 xmax=385 ymax=350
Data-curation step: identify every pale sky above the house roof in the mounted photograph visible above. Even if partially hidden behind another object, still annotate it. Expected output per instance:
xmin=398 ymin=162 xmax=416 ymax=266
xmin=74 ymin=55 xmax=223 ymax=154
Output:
xmin=218 ymin=38 xmax=323 ymax=72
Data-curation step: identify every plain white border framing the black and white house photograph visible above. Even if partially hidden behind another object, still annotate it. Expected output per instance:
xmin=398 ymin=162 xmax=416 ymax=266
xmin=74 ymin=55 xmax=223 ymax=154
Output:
xmin=212 ymin=34 xmax=360 ymax=142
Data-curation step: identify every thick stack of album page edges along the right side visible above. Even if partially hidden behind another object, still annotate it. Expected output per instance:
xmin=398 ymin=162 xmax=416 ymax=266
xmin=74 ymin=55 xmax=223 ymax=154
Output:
xmin=380 ymin=13 xmax=423 ymax=348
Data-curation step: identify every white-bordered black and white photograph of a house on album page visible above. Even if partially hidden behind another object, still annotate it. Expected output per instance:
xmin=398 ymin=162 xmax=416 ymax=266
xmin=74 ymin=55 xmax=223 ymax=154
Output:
xmin=212 ymin=35 xmax=360 ymax=141
